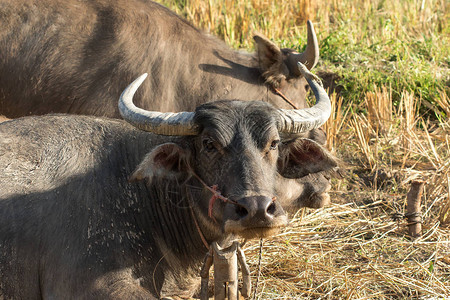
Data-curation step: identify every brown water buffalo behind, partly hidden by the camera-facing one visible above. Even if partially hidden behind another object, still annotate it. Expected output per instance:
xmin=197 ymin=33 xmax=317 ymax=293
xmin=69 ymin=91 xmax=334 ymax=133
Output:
xmin=0 ymin=0 xmax=319 ymax=118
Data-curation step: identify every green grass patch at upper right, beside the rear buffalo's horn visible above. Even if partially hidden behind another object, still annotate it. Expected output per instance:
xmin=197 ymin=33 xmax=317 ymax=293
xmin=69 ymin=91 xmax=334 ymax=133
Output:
xmin=319 ymin=1 xmax=450 ymax=116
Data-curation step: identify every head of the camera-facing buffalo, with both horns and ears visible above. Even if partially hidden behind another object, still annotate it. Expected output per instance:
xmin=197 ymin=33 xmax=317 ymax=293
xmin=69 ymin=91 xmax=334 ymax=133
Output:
xmin=119 ymin=64 xmax=336 ymax=238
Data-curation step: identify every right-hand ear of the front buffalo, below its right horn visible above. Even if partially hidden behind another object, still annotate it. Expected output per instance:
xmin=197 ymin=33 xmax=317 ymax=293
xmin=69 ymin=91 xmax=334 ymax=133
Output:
xmin=278 ymin=138 xmax=338 ymax=178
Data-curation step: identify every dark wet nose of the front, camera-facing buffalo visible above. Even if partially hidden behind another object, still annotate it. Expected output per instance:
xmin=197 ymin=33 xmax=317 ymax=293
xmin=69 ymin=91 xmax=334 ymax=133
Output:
xmin=235 ymin=196 xmax=284 ymax=226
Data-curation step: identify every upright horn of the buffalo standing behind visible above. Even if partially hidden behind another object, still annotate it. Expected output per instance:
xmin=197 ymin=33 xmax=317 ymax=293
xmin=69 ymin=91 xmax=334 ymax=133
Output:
xmin=288 ymin=20 xmax=319 ymax=76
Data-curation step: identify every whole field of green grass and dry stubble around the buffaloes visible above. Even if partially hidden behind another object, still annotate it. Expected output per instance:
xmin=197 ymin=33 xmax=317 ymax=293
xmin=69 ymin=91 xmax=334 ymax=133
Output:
xmin=157 ymin=0 xmax=450 ymax=299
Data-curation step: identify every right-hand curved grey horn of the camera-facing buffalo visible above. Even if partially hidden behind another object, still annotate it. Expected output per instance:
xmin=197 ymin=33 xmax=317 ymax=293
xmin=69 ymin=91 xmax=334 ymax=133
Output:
xmin=278 ymin=63 xmax=331 ymax=133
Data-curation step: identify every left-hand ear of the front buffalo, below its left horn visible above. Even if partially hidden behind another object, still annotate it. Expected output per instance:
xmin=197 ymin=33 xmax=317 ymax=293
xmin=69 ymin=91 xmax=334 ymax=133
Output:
xmin=130 ymin=143 xmax=189 ymax=181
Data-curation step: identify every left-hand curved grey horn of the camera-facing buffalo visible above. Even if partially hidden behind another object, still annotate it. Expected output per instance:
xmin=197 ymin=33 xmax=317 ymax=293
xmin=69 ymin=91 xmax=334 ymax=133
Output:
xmin=119 ymin=73 xmax=198 ymax=135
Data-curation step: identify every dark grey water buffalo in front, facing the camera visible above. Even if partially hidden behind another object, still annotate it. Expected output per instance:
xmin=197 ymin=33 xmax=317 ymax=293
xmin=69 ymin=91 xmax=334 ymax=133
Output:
xmin=0 ymin=63 xmax=336 ymax=299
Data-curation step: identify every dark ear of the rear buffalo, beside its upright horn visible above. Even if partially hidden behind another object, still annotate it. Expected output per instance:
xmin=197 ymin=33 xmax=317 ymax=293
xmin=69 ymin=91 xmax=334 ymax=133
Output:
xmin=253 ymin=34 xmax=289 ymax=88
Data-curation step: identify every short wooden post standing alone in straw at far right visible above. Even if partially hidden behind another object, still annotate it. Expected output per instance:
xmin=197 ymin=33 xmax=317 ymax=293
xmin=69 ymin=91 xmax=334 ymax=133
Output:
xmin=406 ymin=181 xmax=425 ymax=238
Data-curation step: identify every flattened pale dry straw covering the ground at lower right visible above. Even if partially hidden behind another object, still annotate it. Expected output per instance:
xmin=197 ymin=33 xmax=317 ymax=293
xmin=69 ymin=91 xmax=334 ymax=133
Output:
xmin=246 ymin=203 xmax=450 ymax=299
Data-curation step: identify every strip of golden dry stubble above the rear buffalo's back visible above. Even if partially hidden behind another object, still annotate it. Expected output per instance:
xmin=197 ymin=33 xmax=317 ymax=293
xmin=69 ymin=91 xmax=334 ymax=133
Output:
xmin=161 ymin=0 xmax=316 ymax=48
